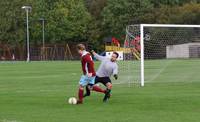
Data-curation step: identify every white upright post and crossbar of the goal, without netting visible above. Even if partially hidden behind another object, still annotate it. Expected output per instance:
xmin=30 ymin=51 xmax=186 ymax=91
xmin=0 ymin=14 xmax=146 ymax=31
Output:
xmin=139 ymin=24 xmax=200 ymax=87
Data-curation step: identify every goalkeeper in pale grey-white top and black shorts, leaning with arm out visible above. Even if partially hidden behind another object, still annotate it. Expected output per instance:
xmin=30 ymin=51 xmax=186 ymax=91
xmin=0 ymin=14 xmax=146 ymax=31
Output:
xmin=84 ymin=51 xmax=119 ymax=102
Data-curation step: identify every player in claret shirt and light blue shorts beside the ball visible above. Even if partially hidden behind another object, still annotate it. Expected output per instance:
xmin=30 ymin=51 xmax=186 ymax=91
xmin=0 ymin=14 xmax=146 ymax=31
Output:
xmin=77 ymin=44 xmax=96 ymax=104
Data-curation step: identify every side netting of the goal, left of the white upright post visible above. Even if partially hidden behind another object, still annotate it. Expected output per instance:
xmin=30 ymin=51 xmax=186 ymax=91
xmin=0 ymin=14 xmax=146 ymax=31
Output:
xmin=117 ymin=26 xmax=140 ymax=86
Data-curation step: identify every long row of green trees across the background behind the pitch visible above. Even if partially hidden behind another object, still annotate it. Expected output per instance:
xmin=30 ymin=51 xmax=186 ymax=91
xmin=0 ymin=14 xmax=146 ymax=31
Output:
xmin=0 ymin=0 xmax=200 ymax=49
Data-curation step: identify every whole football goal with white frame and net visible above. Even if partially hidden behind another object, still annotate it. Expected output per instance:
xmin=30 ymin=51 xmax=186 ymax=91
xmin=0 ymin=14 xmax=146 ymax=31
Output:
xmin=119 ymin=24 xmax=200 ymax=86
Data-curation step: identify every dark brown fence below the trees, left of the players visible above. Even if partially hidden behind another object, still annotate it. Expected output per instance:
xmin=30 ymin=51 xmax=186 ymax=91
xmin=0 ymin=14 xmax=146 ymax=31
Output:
xmin=0 ymin=44 xmax=79 ymax=61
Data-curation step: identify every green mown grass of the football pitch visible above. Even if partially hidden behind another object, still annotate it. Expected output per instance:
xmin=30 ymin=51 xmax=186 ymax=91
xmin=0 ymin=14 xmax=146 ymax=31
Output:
xmin=0 ymin=60 xmax=200 ymax=122
